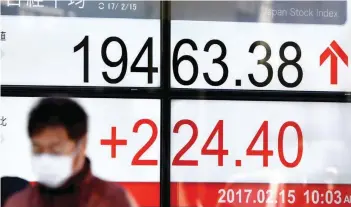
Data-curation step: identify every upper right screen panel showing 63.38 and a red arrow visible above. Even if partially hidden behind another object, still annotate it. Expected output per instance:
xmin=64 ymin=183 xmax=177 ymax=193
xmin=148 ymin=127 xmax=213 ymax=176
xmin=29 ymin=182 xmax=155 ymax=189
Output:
xmin=171 ymin=1 xmax=351 ymax=91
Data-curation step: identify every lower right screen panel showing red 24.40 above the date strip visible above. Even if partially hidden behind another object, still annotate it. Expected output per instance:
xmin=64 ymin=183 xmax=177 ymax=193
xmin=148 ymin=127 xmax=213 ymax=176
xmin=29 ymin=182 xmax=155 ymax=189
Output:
xmin=171 ymin=100 xmax=351 ymax=206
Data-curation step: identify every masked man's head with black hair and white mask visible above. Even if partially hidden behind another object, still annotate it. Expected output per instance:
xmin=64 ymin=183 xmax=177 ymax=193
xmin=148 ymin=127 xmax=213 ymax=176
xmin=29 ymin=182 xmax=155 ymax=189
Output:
xmin=28 ymin=98 xmax=88 ymax=187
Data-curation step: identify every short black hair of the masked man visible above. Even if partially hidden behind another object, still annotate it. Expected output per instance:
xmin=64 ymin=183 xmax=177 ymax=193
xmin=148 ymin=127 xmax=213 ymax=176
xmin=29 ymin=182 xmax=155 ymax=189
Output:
xmin=28 ymin=97 xmax=88 ymax=141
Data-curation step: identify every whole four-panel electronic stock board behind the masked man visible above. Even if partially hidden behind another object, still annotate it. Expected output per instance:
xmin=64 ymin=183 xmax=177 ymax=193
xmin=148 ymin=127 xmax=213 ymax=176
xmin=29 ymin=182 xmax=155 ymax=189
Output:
xmin=0 ymin=0 xmax=351 ymax=207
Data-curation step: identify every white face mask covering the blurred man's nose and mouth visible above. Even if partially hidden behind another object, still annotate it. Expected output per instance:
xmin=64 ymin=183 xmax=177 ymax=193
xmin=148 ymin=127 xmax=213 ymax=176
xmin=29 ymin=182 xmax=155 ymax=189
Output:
xmin=32 ymin=142 xmax=78 ymax=188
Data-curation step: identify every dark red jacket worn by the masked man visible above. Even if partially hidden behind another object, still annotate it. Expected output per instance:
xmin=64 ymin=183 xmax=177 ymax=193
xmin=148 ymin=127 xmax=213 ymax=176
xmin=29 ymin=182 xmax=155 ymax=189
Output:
xmin=5 ymin=159 xmax=136 ymax=207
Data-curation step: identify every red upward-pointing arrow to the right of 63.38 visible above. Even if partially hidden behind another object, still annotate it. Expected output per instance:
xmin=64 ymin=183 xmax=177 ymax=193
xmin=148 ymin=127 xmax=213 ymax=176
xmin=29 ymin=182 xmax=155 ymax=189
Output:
xmin=319 ymin=41 xmax=349 ymax=85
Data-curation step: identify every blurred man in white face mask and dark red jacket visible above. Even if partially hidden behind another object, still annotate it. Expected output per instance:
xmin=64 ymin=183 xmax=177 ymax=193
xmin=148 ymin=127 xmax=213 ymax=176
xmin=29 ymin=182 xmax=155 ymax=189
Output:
xmin=5 ymin=98 xmax=136 ymax=207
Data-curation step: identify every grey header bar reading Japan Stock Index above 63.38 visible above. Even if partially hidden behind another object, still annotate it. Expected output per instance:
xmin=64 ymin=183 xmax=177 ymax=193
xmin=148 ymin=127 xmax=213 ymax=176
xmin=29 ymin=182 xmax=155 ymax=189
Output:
xmin=172 ymin=1 xmax=347 ymax=24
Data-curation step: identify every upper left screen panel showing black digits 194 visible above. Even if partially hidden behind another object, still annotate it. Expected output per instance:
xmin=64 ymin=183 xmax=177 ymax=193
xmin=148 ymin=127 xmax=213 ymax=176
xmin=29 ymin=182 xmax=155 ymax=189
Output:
xmin=1 ymin=1 xmax=160 ymax=87
